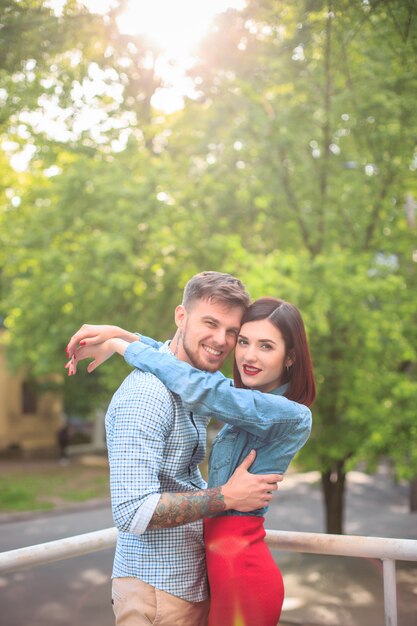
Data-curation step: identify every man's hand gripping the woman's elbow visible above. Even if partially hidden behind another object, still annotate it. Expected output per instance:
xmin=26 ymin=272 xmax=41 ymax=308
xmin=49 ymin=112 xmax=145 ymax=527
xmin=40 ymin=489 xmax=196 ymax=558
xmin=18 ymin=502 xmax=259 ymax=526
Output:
xmin=221 ymin=450 xmax=283 ymax=513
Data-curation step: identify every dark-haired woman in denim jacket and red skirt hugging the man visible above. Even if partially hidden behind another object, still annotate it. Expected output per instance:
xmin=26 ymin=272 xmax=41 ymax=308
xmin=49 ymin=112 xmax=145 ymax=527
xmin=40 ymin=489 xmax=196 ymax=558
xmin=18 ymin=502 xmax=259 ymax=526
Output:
xmin=68 ymin=298 xmax=315 ymax=626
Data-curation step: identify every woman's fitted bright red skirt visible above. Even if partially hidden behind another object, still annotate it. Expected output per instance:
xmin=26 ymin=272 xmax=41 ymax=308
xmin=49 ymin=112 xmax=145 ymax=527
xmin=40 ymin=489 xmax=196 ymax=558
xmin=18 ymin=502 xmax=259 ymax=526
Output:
xmin=204 ymin=515 xmax=284 ymax=626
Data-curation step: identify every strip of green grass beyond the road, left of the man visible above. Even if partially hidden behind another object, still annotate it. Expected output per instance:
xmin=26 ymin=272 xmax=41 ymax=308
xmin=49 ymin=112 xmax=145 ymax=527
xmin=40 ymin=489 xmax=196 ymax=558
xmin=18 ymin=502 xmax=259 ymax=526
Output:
xmin=0 ymin=461 xmax=110 ymax=513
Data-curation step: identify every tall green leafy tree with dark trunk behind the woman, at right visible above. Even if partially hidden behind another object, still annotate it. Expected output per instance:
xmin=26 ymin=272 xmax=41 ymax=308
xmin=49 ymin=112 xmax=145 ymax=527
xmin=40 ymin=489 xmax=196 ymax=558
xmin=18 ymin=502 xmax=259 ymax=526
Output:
xmin=166 ymin=1 xmax=417 ymax=532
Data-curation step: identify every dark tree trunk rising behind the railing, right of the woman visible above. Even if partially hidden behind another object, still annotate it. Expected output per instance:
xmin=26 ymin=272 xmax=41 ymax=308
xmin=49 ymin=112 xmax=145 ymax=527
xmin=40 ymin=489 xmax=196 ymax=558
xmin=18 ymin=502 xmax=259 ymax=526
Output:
xmin=321 ymin=461 xmax=346 ymax=535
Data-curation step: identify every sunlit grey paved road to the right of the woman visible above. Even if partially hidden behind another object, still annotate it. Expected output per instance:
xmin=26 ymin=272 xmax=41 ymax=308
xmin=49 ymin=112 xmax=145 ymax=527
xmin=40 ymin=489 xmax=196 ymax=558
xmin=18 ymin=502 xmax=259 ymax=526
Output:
xmin=266 ymin=468 xmax=417 ymax=626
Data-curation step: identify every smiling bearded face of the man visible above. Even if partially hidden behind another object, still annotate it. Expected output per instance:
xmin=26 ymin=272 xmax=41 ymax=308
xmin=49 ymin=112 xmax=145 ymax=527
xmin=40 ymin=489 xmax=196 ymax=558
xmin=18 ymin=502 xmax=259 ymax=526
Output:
xmin=173 ymin=300 xmax=243 ymax=372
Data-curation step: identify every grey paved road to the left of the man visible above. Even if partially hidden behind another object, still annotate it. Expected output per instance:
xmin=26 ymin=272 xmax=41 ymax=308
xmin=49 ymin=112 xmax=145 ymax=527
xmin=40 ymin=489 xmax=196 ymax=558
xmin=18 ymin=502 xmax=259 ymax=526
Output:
xmin=0 ymin=507 xmax=114 ymax=626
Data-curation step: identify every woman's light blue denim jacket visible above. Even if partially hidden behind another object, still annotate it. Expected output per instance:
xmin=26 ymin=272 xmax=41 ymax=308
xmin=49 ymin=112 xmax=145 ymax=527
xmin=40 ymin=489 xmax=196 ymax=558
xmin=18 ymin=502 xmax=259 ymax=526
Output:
xmin=125 ymin=337 xmax=312 ymax=515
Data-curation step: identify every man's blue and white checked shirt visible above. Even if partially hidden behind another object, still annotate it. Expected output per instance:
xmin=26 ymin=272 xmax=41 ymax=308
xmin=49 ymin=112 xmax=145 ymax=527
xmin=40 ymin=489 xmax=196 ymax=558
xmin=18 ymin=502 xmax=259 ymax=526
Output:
xmin=106 ymin=343 xmax=209 ymax=602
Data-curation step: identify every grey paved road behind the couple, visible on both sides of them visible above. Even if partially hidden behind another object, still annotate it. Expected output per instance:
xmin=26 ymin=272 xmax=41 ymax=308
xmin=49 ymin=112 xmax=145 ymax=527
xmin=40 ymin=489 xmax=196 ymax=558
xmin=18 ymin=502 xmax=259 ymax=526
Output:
xmin=0 ymin=471 xmax=417 ymax=626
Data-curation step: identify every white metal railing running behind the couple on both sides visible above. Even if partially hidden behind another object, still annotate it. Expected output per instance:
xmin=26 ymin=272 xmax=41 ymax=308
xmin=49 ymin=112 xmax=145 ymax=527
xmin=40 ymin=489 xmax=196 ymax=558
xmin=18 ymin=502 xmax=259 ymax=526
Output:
xmin=0 ymin=528 xmax=417 ymax=626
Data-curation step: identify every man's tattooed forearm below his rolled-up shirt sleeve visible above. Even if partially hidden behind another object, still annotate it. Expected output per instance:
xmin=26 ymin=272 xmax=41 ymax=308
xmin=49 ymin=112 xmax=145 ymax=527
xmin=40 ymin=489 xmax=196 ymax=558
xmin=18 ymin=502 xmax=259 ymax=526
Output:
xmin=148 ymin=487 xmax=226 ymax=529
